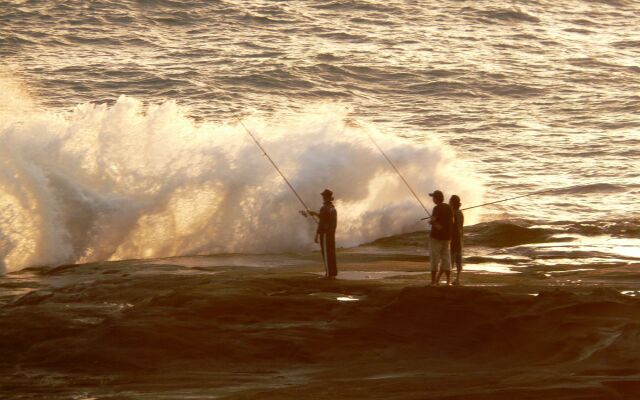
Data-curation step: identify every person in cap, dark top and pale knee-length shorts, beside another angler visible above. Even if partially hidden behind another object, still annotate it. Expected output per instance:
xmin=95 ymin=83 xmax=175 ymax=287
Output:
xmin=429 ymin=190 xmax=453 ymax=286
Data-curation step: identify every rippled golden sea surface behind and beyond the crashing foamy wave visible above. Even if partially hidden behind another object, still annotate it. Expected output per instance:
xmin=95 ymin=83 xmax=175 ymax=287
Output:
xmin=0 ymin=0 xmax=640 ymax=272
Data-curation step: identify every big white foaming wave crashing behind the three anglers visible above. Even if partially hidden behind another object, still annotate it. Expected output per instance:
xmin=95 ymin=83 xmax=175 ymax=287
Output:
xmin=0 ymin=79 xmax=481 ymax=271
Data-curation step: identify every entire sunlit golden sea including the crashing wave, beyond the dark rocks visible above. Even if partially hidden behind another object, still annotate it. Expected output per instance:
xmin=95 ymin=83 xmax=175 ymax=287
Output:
xmin=0 ymin=0 xmax=640 ymax=271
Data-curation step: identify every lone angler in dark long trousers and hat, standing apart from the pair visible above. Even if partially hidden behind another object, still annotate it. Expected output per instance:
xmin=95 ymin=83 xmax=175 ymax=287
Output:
xmin=308 ymin=189 xmax=338 ymax=279
